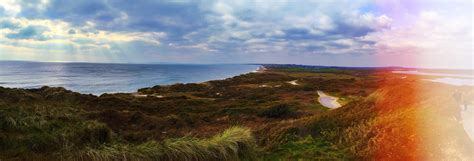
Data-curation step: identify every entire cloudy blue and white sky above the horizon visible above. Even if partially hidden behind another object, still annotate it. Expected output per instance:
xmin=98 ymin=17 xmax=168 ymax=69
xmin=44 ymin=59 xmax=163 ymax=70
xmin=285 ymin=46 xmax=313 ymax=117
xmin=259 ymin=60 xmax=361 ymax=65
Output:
xmin=0 ymin=0 xmax=474 ymax=69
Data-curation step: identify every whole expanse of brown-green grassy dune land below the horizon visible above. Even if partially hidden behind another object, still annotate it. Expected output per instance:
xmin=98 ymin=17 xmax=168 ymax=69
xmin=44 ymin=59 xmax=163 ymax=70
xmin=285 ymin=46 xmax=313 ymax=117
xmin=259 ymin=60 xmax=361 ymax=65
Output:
xmin=0 ymin=65 xmax=474 ymax=160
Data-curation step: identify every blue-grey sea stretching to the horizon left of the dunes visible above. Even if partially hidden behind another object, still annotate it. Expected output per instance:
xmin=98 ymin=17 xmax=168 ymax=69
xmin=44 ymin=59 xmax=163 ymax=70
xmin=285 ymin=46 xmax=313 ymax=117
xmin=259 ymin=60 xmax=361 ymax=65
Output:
xmin=0 ymin=61 xmax=259 ymax=95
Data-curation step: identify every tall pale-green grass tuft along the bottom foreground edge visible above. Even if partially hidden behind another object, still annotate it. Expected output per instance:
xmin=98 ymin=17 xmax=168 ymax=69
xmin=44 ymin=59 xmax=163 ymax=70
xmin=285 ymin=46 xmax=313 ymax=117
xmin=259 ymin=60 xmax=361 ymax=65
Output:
xmin=67 ymin=127 xmax=256 ymax=161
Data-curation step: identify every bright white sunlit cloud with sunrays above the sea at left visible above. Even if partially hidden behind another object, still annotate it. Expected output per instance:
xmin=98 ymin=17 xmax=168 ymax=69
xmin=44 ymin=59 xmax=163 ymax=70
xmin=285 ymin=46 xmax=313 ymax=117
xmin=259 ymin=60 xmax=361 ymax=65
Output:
xmin=0 ymin=17 xmax=166 ymax=62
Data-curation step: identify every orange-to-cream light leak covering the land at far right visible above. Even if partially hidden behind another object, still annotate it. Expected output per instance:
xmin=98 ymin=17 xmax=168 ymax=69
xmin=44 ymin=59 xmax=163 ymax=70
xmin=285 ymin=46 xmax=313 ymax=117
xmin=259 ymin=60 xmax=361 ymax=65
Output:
xmin=369 ymin=71 xmax=474 ymax=161
